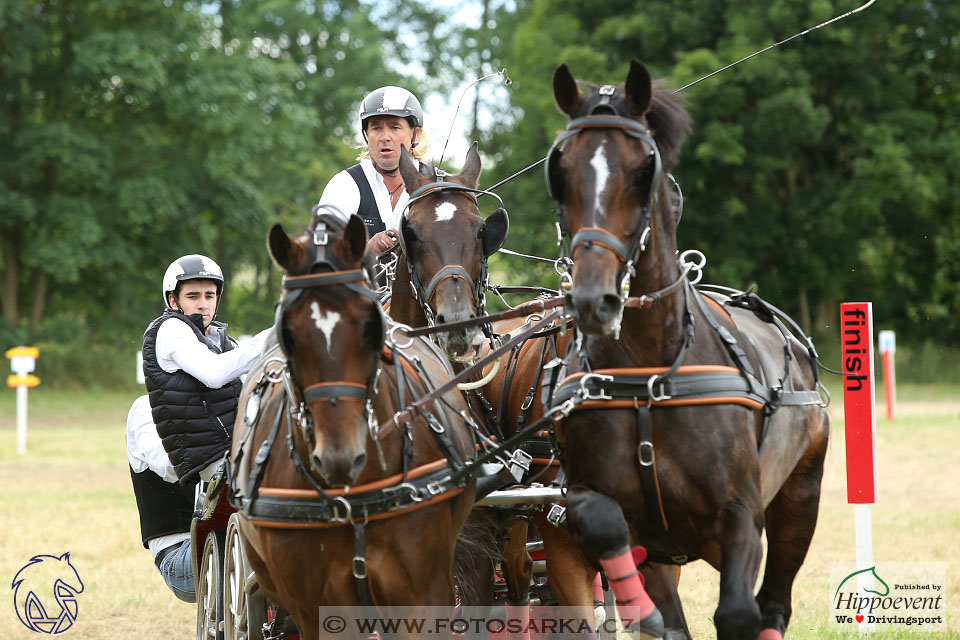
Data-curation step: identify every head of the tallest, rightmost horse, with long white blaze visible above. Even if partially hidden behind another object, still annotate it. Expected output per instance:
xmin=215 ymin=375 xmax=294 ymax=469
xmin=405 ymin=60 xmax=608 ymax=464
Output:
xmin=546 ymin=60 xmax=690 ymax=335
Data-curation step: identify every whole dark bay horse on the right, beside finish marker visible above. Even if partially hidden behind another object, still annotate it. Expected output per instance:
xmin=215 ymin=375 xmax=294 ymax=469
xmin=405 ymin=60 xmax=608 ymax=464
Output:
xmin=546 ymin=60 xmax=828 ymax=640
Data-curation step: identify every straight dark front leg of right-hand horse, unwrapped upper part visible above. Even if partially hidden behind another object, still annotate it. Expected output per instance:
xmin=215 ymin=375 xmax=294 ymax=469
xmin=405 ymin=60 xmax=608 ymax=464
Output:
xmin=713 ymin=500 xmax=763 ymax=640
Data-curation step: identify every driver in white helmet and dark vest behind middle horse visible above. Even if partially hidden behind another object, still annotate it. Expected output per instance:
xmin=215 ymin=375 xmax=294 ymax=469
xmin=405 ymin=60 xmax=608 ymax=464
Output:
xmin=317 ymin=86 xmax=435 ymax=252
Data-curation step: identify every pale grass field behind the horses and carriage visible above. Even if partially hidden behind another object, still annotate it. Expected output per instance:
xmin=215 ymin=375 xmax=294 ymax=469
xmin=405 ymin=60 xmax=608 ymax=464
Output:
xmin=0 ymin=385 xmax=960 ymax=640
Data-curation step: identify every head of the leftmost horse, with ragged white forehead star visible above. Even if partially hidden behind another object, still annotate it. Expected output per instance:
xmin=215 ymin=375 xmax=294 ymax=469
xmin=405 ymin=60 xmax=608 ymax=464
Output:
xmin=267 ymin=214 xmax=385 ymax=486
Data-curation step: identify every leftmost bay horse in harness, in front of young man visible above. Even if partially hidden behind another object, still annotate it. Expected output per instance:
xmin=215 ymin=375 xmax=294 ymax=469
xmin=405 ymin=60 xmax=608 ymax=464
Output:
xmin=230 ymin=215 xmax=475 ymax=638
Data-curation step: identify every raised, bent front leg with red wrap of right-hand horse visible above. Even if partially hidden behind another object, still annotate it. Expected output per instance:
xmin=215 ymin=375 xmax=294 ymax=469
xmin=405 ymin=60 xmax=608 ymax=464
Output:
xmin=567 ymin=487 xmax=663 ymax=638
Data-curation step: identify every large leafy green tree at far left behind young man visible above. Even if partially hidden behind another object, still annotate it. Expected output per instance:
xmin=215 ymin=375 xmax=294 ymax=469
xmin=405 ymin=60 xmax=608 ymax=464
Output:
xmin=0 ymin=0 xmax=315 ymax=335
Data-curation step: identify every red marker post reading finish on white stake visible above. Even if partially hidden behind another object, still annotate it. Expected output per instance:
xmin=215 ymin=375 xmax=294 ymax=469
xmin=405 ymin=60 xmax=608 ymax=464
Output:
xmin=840 ymin=302 xmax=877 ymax=631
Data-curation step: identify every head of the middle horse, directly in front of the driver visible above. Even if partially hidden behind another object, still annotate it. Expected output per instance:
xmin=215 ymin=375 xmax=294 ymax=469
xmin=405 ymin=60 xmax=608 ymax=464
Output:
xmin=400 ymin=143 xmax=509 ymax=360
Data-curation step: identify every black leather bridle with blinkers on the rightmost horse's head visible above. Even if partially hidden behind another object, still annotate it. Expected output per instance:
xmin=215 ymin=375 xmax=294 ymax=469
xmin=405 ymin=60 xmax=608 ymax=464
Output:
xmin=545 ymin=94 xmax=663 ymax=302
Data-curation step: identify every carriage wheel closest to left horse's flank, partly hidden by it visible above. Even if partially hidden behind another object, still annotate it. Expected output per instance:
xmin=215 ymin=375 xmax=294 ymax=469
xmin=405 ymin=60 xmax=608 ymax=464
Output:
xmin=223 ymin=513 xmax=267 ymax=640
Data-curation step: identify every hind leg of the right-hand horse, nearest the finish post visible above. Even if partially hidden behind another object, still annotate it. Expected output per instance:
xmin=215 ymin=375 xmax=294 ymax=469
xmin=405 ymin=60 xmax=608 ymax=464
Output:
xmin=757 ymin=430 xmax=827 ymax=640
